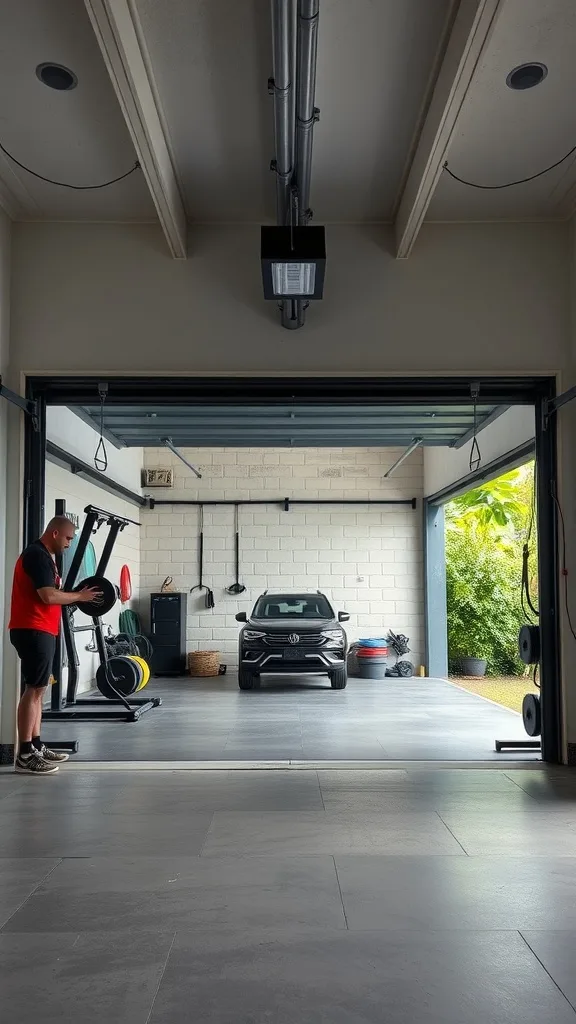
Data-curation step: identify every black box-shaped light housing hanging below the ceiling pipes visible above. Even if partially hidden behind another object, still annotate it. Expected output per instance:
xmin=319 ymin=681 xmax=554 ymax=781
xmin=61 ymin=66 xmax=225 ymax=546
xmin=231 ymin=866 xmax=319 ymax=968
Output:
xmin=260 ymin=224 xmax=326 ymax=300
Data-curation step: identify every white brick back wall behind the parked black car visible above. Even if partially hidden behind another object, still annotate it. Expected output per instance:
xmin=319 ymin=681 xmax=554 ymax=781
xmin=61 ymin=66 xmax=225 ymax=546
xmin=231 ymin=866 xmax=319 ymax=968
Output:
xmin=140 ymin=449 xmax=423 ymax=666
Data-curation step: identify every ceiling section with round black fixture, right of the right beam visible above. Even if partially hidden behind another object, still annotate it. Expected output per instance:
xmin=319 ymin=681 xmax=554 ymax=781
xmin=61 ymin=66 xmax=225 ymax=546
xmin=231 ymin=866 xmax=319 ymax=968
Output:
xmin=428 ymin=0 xmax=576 ymax=220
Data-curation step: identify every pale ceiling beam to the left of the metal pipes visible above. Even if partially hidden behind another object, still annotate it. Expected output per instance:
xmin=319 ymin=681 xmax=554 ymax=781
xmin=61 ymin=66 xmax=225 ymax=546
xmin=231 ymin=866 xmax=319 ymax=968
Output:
xmin=84 ymin=0 xmax=187 ymax=259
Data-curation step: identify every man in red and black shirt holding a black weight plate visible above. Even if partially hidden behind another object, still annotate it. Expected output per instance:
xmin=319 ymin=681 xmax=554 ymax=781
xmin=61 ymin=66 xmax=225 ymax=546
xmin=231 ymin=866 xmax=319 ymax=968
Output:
xmin=8 ymin=516 xmax=101 ymax=775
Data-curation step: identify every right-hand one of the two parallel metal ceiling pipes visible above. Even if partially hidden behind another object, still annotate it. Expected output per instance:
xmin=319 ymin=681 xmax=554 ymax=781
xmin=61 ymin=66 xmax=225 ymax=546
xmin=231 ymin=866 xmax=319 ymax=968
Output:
xmin=295 ymin=0 xmax=320 ymax=225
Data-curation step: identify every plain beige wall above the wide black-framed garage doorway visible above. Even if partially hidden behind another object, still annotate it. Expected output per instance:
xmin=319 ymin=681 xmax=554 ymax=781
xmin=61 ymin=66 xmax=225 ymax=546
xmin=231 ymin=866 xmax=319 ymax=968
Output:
xmin=12 ymin=223 xmax=569 ymax=374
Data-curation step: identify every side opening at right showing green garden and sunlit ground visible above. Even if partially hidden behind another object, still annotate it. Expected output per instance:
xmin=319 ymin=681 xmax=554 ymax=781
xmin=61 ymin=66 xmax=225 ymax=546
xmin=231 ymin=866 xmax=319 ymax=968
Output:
xmin=445 ymin=460 xmax=540 ymax=756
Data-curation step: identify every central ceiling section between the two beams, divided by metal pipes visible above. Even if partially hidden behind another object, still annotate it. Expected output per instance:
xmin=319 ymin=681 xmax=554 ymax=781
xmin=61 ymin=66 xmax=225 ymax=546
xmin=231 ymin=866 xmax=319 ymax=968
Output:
xmin=136 ymin=0 xmax=449 ymax=222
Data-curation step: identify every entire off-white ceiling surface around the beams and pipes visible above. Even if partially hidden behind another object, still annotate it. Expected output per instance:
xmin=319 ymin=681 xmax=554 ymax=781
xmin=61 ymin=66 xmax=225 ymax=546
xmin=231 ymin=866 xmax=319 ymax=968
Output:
xmin=0 ymin=0 xmax=576 ymax=223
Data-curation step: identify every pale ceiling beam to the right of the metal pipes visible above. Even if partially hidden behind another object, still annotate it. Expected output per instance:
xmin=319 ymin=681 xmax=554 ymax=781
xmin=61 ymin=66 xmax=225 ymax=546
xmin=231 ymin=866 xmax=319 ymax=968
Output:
xmin=395 ymin=0 xmax=504 ymax=259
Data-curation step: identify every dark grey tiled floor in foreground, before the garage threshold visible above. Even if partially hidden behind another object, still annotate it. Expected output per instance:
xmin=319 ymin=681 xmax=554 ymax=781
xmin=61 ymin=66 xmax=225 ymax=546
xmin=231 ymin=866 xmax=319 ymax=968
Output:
xmin=0 ymin=765 xmax=576 ymax=1024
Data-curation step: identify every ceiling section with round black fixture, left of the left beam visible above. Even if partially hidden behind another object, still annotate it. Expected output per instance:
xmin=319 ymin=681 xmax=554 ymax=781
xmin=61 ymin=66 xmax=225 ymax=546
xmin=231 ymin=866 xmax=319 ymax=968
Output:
xmin=0 ymin=0 xmax=155 ymax=220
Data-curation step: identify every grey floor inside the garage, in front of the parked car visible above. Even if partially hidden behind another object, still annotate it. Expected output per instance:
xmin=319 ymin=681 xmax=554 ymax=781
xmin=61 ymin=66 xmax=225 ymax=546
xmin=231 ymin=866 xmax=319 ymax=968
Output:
xmin=43 ymin=674 xmax=536 ymax=763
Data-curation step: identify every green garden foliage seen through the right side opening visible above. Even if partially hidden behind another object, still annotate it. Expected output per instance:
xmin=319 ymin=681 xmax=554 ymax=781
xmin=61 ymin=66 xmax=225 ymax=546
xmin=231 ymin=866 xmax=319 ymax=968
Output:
xmin=446 ymin=465 xmax=537 ymax=675
